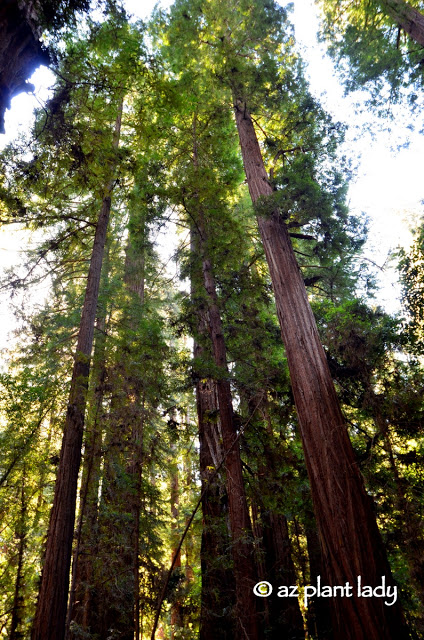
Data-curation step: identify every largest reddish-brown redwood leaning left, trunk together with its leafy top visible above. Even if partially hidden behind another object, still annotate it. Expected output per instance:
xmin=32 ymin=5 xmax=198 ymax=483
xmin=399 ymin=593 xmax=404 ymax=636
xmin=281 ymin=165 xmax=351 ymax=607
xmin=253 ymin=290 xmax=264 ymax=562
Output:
xmin=161 ymin=2 xmax=407 ymax=640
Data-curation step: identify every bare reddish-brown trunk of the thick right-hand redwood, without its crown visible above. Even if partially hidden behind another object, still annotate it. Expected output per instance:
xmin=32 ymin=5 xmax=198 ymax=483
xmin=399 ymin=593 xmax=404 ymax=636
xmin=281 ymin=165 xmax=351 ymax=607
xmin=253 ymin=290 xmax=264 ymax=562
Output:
xmin=234 ymin=95 xmax=408 ymax=640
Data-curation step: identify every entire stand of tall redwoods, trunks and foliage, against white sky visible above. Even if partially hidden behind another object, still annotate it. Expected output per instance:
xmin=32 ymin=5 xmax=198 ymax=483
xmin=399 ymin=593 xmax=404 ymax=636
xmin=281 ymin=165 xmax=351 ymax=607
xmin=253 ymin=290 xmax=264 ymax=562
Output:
xmin=0 ymin=0 xmax=424 ymax=640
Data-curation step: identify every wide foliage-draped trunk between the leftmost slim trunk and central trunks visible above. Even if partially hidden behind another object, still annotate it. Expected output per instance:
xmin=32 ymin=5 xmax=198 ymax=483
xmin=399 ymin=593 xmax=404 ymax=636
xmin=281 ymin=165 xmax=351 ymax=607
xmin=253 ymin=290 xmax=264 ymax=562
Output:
xmin=83 ymin=212 xmax=145 ymax=640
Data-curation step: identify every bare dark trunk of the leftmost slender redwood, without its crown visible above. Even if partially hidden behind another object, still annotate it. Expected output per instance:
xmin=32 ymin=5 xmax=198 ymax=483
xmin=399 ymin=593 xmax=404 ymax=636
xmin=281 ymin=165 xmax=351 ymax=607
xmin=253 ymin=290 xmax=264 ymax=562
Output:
xmin=31 ymin=101 xmax=122 ymax=640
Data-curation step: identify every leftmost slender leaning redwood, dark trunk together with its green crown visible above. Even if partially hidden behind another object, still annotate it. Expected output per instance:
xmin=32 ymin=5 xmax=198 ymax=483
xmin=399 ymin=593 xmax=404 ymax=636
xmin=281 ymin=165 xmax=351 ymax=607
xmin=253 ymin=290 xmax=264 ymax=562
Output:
xmin=32 ymin=14 xmax=146 ymax=640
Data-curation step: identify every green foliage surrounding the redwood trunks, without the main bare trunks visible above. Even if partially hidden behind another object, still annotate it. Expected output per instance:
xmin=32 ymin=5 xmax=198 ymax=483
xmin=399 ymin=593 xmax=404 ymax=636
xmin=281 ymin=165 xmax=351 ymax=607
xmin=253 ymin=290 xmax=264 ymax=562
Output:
xmin=0 ymin=0 xmax=424 ymax=640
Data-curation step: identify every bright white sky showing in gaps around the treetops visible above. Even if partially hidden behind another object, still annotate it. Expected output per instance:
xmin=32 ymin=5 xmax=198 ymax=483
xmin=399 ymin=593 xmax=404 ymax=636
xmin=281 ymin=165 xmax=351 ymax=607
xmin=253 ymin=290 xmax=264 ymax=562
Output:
xmin=0 ymin=0 xmax=424 ymax=346
